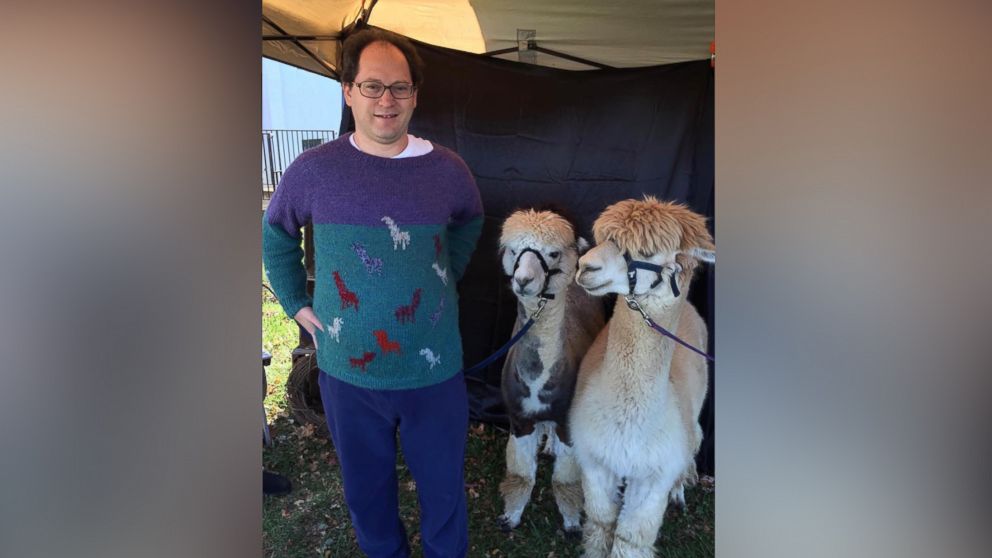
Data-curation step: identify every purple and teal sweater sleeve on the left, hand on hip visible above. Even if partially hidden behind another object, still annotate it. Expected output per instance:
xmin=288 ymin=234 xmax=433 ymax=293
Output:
xmin=262 ymin=161 xmax=313 ymax=318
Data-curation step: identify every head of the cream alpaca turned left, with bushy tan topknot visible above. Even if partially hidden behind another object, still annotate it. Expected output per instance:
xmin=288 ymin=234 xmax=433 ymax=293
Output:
xmin=575 ymin=196 xmax=716 ymax=298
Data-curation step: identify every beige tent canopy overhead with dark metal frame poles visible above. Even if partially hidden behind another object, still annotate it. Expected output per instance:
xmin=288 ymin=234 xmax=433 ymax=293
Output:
xmin=262 ymin=0 xmax=714 ymax=79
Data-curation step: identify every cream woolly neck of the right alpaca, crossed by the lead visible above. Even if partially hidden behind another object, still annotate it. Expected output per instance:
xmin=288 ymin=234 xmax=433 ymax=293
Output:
xmin=606 ymin=296 xmax=684 ymax=396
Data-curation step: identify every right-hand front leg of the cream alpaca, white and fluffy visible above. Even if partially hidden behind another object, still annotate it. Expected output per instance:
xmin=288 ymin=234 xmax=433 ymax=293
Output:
xmin=610 ymin=471 xmax=681 ymax=558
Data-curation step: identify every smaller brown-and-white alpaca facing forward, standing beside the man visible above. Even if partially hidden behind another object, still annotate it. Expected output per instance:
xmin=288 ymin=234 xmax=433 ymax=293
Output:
xmin=499 ymin=210 xmax=605 ymax=537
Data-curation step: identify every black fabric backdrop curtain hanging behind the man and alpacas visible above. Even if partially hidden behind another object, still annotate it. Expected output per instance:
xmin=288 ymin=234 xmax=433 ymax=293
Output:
xmin=341 ymin=43 xmax=715 ymax=474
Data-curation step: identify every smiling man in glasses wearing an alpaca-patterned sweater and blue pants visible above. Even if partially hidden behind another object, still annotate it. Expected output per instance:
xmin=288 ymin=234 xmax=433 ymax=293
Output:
xmin=263 ymin=29 xmax=482 ymax=558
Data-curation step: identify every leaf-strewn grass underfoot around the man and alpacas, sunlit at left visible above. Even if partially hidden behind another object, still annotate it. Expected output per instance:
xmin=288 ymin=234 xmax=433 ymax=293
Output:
xmin=262 ymin=290 xmax=715 ymax=558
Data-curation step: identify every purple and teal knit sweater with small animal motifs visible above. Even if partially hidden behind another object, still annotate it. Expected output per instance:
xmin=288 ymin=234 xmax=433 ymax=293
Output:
xmin=262 ymin=135 xmax=482 ymax=389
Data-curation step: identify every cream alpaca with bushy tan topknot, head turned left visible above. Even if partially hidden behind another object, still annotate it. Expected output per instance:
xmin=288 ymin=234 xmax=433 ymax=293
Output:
xmin=569 ymin=196 xmax=715 ymax=558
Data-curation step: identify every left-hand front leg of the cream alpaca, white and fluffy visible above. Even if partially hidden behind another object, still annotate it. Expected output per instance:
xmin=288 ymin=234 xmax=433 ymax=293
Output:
xmin=581 ymin=465 xmax=620 ymax=558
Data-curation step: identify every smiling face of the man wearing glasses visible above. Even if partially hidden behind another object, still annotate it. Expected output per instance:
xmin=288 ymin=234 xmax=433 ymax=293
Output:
xmin=344 ymin=42 xmax=417 ymax=150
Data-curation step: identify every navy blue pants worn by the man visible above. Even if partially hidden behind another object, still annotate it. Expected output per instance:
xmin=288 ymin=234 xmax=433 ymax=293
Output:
xmin=318 ymin=372 xmax=468 ymax=558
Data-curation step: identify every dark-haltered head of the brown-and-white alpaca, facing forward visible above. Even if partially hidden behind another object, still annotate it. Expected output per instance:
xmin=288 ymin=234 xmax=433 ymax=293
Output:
xmin=499 ymin=209 xmax=589 ymax=298
